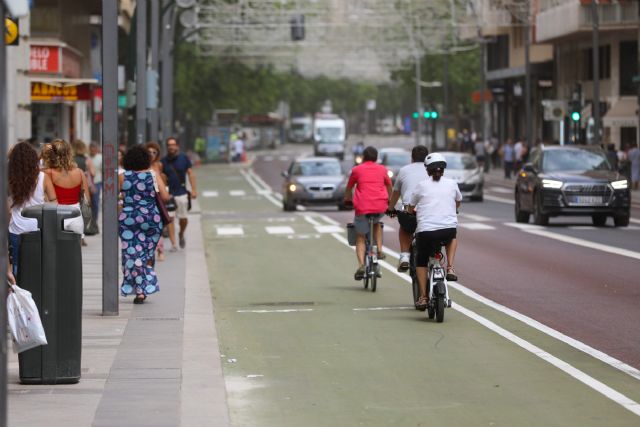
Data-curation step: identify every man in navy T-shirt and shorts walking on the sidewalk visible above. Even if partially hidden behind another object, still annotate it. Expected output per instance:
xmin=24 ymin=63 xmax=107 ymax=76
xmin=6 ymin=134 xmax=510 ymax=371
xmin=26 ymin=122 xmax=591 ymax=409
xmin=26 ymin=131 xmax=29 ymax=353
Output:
xmin=162 ymin=137 xmax=198 ymax=252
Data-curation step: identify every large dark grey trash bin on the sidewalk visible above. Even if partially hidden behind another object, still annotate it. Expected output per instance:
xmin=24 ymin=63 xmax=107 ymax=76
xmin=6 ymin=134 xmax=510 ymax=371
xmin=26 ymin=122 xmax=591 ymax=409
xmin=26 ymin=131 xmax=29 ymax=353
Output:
xmin=18 ymin=203 xmax=82 ymax=384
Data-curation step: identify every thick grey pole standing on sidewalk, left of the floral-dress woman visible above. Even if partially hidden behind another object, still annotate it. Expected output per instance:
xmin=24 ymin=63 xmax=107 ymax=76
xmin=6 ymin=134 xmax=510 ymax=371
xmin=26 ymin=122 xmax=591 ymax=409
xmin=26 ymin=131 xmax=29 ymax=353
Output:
xmin=102 ymin=0 xmax=119 ymax=316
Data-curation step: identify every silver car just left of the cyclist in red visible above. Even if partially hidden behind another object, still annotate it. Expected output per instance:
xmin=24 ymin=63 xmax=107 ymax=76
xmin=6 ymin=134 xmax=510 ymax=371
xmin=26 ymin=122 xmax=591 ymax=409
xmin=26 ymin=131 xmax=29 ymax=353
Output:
xmin=282 ymin=157 xmax=348 ymax=211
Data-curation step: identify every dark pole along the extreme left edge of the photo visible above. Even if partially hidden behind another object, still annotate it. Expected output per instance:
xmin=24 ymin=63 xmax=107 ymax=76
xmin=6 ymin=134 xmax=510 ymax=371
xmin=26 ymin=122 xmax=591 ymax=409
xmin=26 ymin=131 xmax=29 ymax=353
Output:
xmin=0 ymin=0 xmax=9 ymax=427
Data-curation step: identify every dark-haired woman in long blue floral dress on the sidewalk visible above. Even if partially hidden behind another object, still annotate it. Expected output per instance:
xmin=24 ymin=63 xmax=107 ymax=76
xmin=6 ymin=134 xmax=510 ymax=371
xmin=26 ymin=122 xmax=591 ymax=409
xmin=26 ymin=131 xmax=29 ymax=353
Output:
xmin=118 ymin=145 xmax=170 ymax=304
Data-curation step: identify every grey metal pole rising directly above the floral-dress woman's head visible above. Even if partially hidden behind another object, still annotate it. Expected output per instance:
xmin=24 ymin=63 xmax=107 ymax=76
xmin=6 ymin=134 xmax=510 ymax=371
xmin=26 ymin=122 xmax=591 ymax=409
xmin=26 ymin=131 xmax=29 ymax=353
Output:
xmin=136 ymin=0 xmax=148 ymax=144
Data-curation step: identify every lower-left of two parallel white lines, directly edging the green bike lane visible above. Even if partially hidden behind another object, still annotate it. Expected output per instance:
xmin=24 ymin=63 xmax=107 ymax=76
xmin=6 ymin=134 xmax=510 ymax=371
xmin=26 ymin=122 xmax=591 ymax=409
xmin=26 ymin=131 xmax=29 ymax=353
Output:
xmin=332 ymin=234 xmax=640 ymax=416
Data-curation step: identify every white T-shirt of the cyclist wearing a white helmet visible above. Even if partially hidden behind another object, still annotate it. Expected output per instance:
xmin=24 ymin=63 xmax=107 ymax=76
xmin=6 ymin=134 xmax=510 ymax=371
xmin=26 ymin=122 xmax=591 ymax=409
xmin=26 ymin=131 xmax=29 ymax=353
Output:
xmin=411 ymin=177 xmax=462 ymax=233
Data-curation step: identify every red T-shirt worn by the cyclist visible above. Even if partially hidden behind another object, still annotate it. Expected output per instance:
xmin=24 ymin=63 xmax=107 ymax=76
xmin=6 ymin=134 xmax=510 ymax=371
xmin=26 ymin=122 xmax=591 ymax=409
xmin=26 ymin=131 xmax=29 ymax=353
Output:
xmin=347 ymin=162 xmax=391 ymax=215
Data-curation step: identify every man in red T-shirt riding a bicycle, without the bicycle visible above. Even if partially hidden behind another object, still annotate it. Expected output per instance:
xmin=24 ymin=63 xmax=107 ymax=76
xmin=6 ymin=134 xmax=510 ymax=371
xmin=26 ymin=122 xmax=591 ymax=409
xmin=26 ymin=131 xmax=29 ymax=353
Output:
xmin=344 ymin=147 xmax=392 ymax=280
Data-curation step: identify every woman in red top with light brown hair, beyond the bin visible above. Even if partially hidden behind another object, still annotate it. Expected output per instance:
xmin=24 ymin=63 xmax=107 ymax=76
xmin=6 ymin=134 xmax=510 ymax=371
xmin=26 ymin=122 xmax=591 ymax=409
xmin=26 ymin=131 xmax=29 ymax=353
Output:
xmin=44 ymin=139 xmax=91 ymax=242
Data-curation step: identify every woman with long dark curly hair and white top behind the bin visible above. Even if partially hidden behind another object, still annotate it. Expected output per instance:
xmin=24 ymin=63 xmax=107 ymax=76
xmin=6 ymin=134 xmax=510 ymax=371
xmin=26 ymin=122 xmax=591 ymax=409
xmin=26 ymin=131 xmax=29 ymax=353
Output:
xmin=8 ymin=142 xmax=56 ymax=276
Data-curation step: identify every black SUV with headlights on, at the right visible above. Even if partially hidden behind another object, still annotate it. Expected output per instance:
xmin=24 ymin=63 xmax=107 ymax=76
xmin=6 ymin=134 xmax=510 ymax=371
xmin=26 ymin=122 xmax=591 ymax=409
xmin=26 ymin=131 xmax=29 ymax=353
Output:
xmin=515 ymin=145 xmax=631 ymax=227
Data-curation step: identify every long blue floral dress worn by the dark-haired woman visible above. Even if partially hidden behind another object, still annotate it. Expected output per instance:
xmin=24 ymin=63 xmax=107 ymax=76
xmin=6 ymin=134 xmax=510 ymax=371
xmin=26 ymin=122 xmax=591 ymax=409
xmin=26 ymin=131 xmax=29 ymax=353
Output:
xmin=118 ymin=171 xmax=162 ymax=296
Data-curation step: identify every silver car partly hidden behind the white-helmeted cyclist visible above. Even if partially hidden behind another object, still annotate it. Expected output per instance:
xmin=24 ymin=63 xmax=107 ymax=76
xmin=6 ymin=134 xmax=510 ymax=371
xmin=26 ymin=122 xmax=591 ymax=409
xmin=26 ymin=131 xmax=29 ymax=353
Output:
xmin=440 ymin=151 xmax=484 ymax=202
